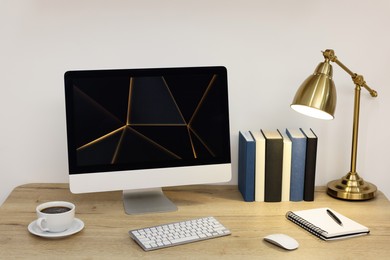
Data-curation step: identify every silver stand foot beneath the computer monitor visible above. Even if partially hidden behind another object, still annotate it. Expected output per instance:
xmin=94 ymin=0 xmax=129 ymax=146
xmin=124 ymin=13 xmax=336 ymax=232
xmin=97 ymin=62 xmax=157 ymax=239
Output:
xmin=123 ymin=188 xmax=177 ymax=215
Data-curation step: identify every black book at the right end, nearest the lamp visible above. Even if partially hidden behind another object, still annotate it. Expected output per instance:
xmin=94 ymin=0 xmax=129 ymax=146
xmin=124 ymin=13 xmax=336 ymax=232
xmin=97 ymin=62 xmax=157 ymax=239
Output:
xmin=301 ymin=129 xmax=318 ymax=201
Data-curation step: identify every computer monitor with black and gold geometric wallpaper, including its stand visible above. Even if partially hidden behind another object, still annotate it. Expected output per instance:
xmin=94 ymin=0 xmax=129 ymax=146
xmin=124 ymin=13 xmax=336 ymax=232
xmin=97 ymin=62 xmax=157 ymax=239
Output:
xmin=64 ymin=67 xmax=231 ymax=214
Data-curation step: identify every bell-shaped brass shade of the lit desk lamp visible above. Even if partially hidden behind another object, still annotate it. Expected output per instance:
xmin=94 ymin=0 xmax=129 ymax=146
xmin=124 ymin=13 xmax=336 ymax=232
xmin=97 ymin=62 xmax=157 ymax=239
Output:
xmin=291 ymin=60 xmax=337 ymax=120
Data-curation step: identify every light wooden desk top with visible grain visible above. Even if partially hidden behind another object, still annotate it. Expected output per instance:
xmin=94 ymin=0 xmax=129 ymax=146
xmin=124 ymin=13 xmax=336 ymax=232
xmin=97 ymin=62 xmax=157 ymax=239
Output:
xmin=0 ymin=184 xmax=390 ymax=260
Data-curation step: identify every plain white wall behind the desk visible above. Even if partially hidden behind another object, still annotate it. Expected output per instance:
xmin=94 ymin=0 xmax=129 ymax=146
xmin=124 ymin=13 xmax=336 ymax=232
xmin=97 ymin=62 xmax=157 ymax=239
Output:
xmin=0 ymin=0 xmax=390 ymax=204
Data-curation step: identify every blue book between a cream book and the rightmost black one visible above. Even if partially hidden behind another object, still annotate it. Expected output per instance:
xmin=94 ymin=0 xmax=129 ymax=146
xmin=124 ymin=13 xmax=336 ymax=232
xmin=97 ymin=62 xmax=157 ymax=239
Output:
xmin=286 ymin=129 xmax=306 ymax=201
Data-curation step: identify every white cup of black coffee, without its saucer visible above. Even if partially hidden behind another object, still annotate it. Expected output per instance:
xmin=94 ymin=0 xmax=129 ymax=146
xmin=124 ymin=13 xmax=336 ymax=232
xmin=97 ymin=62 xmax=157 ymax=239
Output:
xmin=36 ymin=201 xmax=76 ymax=233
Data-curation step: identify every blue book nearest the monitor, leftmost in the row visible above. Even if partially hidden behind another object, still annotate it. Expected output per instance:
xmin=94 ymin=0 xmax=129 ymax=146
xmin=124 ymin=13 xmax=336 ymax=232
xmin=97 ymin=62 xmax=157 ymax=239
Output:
xmin=238 ymin=131 xmax=255 ymax=202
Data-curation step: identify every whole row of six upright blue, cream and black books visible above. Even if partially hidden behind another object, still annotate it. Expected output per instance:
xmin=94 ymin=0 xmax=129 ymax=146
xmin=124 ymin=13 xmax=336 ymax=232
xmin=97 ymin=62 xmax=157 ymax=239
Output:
xmin=238 ymin=128 xmax=318 ymax=202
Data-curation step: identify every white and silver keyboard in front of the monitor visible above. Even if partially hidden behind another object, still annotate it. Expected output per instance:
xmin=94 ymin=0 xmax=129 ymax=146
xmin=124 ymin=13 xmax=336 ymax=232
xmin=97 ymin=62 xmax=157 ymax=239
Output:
xmin=129 ymin=217 xmax=231 ymax=251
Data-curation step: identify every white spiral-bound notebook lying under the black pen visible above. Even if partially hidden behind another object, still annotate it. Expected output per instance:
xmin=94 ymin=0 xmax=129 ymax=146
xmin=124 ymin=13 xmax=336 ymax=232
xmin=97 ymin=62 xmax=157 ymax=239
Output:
xmin=286 ymin=208 xmax=370 ymax=240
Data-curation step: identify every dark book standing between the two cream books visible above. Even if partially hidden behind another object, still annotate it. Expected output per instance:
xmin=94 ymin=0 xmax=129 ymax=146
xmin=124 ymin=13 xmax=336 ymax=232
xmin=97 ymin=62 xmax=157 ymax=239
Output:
xmin=263 ymin=131 xmax=283 ymax=202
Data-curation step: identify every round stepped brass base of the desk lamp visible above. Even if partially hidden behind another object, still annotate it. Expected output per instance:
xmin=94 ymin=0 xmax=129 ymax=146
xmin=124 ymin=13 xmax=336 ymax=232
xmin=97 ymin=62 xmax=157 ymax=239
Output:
xmin=327 ymin=172 xmax=377 ymax=200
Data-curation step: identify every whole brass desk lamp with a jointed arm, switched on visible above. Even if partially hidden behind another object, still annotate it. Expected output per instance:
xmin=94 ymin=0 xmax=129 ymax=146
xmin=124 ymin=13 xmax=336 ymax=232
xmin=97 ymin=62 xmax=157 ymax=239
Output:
xmin=291 ymin=50 xmax=378 ymax=200
